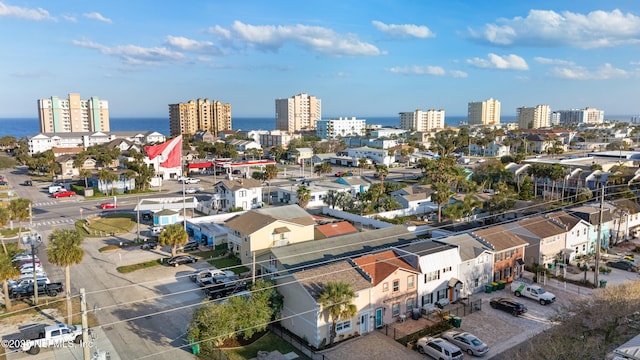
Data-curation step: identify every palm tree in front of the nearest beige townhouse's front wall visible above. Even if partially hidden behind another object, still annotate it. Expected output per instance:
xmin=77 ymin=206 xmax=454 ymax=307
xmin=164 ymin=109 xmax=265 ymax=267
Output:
xmin=318 ymin=282 xmax=358 ymax=345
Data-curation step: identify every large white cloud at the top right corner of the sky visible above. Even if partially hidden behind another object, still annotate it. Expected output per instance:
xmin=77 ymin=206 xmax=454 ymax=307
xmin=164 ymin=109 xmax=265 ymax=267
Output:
xmin=469 ymin=9 xmax=640 ymax=49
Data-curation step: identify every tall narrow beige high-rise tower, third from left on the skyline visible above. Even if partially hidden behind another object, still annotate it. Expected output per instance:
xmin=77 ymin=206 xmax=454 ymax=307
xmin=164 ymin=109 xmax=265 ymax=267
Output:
xmin=276 ymin=93 xmax=322 ymax=132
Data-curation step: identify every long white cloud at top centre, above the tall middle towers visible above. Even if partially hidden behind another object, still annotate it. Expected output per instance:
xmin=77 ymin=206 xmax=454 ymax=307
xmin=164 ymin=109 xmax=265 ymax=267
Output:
xmin=208 ymin=21 xmax=385 ymax=56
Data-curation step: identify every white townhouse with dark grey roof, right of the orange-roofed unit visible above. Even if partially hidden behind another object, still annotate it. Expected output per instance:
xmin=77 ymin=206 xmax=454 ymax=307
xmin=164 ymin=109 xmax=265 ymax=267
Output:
xmin=396 ymin=240 xmax=462 ymax=307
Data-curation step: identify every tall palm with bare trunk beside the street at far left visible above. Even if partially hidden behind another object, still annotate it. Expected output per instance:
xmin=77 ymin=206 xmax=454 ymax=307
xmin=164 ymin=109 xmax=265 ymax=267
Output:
xmin=47 ymin=229 xmax=84 ymax=324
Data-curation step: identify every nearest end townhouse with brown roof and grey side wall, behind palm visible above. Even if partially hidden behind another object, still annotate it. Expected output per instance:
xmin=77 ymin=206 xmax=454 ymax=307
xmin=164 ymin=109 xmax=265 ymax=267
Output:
xmin=275 ymin=260 xmax=375 ymax=348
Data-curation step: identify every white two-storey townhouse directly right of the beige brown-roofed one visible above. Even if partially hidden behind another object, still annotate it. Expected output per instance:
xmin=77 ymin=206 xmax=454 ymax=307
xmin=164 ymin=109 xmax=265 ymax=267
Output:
xmin=544 ymin=211 xmax=591 ymax=264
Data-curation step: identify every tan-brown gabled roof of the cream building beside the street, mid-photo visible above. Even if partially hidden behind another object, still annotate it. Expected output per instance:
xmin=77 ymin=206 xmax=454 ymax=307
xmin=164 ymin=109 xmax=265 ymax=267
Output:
xmin=224 ymin=205 xmax=316 ymax=234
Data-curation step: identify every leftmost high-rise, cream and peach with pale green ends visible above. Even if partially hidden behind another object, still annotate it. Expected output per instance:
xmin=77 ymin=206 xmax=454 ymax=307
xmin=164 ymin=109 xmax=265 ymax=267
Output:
xmin=38 ymin=94 xmax=110 ymax=133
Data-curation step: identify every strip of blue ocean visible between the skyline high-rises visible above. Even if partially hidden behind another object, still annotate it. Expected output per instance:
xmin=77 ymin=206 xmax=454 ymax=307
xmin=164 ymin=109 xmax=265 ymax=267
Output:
xmin=0 ymin=116 xmax=515 ymax=139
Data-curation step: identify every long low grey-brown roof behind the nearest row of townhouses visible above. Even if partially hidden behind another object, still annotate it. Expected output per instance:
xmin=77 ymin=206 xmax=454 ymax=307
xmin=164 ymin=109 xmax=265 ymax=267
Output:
xmin=267 ymin=225 xmax=416 ymax=271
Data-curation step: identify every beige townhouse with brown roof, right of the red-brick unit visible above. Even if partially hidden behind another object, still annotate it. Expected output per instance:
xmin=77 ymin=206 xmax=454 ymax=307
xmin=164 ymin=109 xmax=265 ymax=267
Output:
xmin=504 ymin=215 xmax=568 ymax=268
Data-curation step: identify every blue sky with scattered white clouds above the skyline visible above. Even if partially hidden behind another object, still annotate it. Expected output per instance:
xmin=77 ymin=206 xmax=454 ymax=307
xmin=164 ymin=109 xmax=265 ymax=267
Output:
xmin=0 ymin=0 xmax=640 ymax=120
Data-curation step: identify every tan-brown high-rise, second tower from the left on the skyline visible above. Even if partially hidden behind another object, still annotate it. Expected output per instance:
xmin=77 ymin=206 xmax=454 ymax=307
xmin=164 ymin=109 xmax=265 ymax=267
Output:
xmin=169 ymin=99 xmax=232 ymax=136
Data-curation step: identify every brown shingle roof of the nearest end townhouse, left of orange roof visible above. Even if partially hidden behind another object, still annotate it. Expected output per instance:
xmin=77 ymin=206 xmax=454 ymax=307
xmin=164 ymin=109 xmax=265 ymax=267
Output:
xmin=293 ymin=260 xmax=371 ymax=300
